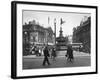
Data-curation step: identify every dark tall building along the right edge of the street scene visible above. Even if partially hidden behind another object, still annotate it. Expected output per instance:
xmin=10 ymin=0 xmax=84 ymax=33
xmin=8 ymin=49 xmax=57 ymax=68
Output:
xmin=73 ymin=17 xmax=91 ymax=53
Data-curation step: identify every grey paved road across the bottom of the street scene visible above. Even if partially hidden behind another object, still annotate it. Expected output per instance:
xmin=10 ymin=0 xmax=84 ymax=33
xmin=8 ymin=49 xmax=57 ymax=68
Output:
xmin=23 ymin=52 xmax=91 ymax=69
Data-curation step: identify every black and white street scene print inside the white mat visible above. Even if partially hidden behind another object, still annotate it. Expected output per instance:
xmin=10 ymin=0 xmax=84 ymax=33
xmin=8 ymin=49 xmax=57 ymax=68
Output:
xmin=22 ymin=10 xmax=91 ymax=69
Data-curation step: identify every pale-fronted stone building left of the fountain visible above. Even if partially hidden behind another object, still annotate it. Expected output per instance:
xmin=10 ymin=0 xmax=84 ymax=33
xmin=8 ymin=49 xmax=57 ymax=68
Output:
xmin=23 ymin=20 xmax=54 ymax=55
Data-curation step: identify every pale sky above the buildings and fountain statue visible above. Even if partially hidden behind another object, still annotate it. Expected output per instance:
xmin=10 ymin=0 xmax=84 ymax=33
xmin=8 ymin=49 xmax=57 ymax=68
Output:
xmin=23 ymin=10 xmax=91 ymax=36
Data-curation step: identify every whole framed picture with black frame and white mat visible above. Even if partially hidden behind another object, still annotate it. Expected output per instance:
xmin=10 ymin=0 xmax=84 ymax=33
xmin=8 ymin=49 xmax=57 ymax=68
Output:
xmin=12 ymin=1 xmax=97 ymax=78
